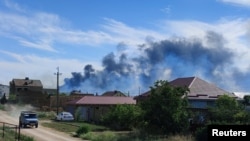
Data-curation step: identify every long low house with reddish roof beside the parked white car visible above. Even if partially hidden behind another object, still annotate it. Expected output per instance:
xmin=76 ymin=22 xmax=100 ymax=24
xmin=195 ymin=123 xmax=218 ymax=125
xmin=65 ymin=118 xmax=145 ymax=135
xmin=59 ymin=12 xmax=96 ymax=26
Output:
xmin=66 ymin=96 xmax=136 ymax=122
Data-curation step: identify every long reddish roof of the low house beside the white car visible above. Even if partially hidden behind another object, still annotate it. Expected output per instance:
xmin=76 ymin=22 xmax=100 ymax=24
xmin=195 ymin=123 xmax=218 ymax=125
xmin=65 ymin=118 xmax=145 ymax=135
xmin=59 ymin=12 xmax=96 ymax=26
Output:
xmin=67 ymin=96 xmax=136 ymax=105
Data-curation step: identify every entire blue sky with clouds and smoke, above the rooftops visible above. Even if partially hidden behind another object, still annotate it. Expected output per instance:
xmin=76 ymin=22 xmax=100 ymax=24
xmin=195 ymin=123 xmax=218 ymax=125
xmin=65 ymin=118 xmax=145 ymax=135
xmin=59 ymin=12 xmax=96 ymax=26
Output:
xmin=0 ymin=0 xmax=250 ymax=95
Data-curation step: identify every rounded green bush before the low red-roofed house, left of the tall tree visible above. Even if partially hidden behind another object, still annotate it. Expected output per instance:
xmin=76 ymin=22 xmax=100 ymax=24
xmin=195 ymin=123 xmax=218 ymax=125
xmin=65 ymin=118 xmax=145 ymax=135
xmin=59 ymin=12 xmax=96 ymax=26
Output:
xmin=101 ymin=104 xmax=141 ymax=130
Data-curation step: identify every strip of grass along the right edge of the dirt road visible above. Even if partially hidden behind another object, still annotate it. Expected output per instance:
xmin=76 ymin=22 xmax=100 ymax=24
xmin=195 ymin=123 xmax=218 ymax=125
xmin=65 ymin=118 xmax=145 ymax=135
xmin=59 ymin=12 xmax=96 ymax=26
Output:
xmin=38 ymin=112 xmax=195 ymax=141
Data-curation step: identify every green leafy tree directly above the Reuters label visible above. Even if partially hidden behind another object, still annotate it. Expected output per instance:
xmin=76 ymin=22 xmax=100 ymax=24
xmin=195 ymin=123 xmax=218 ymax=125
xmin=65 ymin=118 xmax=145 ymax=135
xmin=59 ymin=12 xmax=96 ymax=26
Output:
xmin=195 ymin=94 xmax=250 ymax=141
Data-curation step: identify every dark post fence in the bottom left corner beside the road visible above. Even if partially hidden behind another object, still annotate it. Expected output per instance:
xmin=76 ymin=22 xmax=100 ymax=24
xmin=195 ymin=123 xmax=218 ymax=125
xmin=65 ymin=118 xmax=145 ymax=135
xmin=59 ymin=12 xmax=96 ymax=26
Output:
xmin=0 ymin=122 xmax=20 ymax=141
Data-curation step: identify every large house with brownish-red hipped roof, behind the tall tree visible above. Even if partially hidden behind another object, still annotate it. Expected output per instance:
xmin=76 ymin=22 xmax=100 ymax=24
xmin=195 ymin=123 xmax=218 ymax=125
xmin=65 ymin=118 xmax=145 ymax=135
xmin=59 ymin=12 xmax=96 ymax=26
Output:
xmin=135 ymin=77 xmax=242 ymax=111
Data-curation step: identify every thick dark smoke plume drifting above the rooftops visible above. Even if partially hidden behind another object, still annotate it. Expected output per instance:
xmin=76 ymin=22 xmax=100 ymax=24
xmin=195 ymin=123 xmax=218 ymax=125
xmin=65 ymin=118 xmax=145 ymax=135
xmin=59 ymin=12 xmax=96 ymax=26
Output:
xmin=61 ymin=31 xmax=240 ymax=95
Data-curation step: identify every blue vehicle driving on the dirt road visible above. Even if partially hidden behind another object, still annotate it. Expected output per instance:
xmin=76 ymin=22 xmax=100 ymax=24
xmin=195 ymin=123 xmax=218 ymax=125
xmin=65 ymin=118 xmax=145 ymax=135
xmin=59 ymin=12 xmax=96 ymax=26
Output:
xmin=19 ymin=111 xmax=39 ymax=128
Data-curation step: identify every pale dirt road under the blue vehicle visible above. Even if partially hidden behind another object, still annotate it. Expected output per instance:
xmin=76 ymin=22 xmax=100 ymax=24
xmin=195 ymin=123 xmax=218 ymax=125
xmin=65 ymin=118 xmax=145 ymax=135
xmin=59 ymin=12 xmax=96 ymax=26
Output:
xmin=0 ymin=104 xmax=83 ymax=141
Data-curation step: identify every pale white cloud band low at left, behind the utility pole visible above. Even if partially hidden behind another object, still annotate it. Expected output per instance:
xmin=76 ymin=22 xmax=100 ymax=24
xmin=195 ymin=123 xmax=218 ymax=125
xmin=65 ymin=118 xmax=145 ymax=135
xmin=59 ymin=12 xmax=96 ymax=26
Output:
xmin=0 ymin=50 xmax=100 ymax=88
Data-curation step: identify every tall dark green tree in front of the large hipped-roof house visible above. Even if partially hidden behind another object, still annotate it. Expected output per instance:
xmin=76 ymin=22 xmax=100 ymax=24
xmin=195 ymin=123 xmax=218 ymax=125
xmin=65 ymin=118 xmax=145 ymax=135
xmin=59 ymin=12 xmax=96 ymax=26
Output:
xmin=140 ymin=80 xmax=189 ymax=135
